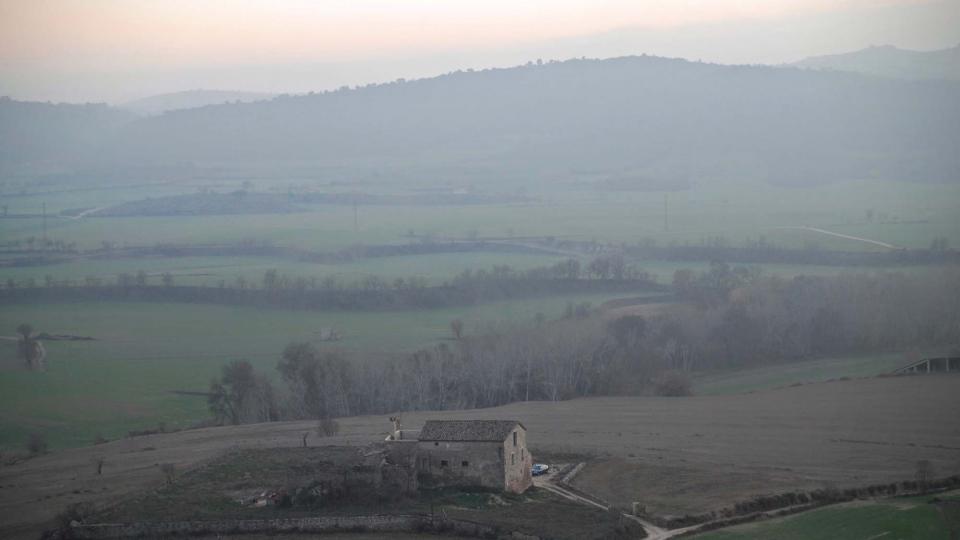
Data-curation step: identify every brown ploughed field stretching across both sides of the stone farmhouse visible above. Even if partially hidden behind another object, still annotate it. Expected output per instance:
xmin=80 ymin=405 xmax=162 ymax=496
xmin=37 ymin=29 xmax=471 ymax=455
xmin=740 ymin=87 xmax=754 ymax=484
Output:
xmin=0 ymin=375 xmax=960 ymax=538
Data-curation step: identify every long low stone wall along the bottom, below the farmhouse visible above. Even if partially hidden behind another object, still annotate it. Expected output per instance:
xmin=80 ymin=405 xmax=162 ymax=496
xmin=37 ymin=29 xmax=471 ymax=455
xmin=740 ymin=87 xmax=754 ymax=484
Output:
xmin=70 ymin=515 xmax=540 ymax=540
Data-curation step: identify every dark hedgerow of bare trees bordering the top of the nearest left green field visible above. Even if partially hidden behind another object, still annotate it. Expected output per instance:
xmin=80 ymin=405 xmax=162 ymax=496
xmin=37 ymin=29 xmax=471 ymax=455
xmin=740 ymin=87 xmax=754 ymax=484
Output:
xmin=0 ymin=262 xmax=667 ymax=309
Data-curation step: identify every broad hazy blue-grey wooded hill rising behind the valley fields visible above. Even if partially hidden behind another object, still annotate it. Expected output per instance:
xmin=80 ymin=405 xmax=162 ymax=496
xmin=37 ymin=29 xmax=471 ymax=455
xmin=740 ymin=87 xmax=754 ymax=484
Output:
xmin=0 ymin=56 xmax=960 ymax=188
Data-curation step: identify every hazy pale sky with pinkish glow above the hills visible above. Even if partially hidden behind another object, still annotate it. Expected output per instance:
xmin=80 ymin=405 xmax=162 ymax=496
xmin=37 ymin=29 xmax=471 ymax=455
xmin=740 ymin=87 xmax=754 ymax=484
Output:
xmin=0 ymin=0 xmax=960 ymax=102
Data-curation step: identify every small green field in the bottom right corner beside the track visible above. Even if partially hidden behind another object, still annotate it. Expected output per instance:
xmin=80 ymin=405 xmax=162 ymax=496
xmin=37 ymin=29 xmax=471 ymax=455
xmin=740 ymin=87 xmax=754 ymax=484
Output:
xmin=695 ymin=492 xmax=960 ymax=540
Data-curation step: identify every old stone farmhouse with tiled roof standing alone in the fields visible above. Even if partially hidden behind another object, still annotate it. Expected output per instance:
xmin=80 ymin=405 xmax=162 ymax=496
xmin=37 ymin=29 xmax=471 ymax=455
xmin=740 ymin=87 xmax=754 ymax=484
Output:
xmin=387 ymin=420 xmax=533 ymax=493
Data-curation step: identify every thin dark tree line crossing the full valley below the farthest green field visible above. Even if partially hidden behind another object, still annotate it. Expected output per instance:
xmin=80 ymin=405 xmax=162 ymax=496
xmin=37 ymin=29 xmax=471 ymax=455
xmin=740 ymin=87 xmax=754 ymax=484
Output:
xmin=0 ymin=231 xmax=960 ymax=284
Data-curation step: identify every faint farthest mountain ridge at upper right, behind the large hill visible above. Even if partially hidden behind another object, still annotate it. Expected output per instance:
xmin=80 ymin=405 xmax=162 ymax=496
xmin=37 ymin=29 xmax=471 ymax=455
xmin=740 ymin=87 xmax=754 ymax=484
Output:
xmin=792 ymin=45 xmax=960 ymax=81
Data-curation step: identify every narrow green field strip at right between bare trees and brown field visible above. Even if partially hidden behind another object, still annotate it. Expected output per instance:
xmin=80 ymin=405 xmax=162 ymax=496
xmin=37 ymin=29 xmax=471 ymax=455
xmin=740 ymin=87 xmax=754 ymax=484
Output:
xmin=693 ymin=352 xmax=928 ymax=396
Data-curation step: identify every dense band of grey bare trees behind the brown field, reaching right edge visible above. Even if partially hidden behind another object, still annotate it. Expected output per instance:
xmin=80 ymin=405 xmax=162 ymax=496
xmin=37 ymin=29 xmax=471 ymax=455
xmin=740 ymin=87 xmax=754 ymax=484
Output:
xmin=212 ymin=265 xmax=960 ymax=422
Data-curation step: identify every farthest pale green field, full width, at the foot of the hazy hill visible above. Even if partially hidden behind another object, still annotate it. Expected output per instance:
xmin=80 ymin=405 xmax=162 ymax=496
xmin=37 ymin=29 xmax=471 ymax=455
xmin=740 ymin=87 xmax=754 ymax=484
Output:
xmin=7 ymin=182 xmax=960 ymax=250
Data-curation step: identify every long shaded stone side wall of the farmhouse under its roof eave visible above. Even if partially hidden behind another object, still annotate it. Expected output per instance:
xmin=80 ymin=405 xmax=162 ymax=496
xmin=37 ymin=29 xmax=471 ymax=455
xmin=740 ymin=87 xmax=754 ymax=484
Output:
xmin=417 ymin=441 xmax=504 ymax=490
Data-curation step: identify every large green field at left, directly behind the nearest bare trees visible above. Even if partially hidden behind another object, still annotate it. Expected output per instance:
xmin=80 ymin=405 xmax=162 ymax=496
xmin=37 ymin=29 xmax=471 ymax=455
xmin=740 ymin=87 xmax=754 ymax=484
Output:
xmin=0 ymin=295 xmax=632 ymax=448
